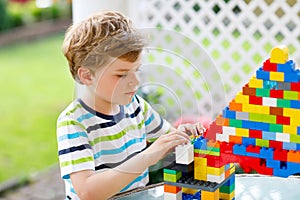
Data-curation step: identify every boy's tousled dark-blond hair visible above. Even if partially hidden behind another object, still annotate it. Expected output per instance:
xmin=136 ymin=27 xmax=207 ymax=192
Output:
xmin=62 ymin=11 xmax=145 ymax=83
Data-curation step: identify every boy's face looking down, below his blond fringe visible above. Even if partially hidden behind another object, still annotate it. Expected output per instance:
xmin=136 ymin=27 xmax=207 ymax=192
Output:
xmin=93 ymin=58 xmax=141 ymax=105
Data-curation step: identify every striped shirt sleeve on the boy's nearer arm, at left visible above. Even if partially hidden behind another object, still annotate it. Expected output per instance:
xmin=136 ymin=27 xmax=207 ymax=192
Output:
xmin=57 ymin=112 xmax=95 ymax=179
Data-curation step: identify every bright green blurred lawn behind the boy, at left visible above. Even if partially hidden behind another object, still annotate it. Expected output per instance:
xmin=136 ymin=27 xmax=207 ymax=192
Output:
xmin=0 ymin=33 xmax=74 ymax=182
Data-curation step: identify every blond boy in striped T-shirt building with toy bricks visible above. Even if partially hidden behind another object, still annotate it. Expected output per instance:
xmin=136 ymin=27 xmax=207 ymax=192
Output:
xmin=57 ymin=11 xmax=202 ymax=200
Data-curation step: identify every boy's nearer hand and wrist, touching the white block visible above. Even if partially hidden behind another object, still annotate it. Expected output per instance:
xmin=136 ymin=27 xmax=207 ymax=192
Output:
xmin=143 ymin=129 xmax=190 ymax=165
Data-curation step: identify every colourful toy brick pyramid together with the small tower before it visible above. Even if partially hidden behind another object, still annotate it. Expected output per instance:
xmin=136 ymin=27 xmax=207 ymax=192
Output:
xmin=164 ymin=46 xmax=300 ymax=200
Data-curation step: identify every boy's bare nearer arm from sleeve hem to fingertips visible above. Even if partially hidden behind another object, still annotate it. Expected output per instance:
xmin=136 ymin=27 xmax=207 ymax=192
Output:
xmin=70 ymin=130 xmax=189 ymax=200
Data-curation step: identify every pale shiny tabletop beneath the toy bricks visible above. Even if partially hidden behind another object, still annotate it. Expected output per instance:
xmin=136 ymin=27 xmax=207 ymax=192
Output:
xmin=115 ymin=175 xmax=300 ymax=200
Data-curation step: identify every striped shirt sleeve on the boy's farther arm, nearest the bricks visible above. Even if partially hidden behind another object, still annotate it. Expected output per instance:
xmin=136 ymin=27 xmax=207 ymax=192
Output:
xmin=136 ymin=96 xmax=171 ymax=142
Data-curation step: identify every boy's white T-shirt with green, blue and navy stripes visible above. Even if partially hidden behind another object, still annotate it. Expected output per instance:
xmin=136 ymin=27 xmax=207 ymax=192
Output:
xmin=57 ymin=96 xmax=170 ymax=199
